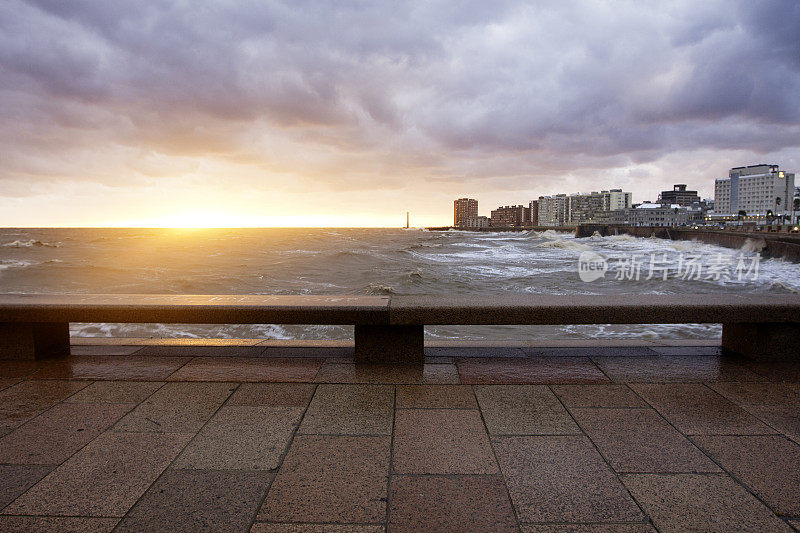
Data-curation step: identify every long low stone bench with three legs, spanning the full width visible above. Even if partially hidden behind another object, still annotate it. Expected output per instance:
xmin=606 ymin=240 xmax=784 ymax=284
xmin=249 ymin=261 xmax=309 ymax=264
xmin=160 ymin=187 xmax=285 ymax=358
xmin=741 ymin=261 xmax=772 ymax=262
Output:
xmin=0 ymin=294 xmax=800 ymax=362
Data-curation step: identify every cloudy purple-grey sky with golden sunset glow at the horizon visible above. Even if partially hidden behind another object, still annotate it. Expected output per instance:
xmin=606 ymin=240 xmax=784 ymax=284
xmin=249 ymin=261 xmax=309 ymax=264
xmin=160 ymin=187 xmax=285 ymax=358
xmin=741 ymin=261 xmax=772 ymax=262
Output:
xmin=0 ymin=0 xmax=800 ymax=227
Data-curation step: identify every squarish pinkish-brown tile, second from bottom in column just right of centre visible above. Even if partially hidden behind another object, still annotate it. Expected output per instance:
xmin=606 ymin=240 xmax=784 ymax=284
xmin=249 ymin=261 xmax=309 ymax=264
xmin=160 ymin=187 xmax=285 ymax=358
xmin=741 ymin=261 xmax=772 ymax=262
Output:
xmin=394 ymin=409 xmax=498 ymax=474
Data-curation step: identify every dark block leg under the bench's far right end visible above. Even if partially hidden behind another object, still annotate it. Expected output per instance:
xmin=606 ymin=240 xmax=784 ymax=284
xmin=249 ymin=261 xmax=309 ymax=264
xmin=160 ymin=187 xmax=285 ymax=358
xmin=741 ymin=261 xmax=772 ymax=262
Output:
xmin=722 ymin=322 xmax=800 ymax=361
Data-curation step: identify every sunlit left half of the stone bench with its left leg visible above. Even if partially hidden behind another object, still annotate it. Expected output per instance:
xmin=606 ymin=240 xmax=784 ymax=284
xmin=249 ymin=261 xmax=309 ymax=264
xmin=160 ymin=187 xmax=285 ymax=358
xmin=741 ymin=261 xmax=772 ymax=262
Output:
xmin=0 ymin=294 xmax=389 ymax=359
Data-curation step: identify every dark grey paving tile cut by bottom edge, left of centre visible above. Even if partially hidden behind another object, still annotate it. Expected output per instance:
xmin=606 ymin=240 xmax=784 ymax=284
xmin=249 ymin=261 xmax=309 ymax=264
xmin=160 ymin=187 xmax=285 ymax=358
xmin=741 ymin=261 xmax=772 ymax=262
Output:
xmin=115 ymin=470 xmax=272 ymax=533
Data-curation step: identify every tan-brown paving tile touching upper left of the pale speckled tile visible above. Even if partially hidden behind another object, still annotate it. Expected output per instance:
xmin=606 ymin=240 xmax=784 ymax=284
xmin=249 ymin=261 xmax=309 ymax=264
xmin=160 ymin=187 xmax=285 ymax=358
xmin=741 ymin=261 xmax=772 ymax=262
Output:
xmin=114 ymin=383 xmax=236 ymax=433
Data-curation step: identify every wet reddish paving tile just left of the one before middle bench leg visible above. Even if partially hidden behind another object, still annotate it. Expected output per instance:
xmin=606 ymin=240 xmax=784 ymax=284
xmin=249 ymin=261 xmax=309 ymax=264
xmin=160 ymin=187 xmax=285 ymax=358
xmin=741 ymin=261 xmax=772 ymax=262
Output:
xmin=169 ymin=357 xmax=323 ymax=383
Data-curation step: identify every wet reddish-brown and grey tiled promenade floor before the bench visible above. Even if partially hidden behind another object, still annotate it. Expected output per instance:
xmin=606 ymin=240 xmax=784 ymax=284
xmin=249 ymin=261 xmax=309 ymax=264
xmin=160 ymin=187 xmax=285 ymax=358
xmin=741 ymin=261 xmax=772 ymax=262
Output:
xmin=0 ymin=341 xmax=800 ymax=533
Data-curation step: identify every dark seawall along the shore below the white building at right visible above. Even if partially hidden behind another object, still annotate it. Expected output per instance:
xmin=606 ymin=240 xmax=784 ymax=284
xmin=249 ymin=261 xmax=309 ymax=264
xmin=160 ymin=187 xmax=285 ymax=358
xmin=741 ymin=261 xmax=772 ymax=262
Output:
xmin=575 ymin=224 xmax=800 ymax=263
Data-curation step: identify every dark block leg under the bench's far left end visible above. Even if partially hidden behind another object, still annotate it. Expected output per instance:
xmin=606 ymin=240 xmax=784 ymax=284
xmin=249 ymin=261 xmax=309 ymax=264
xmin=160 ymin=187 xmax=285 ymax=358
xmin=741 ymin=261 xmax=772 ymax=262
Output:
xmin=0 ymin=322 xmax=69 ymax=359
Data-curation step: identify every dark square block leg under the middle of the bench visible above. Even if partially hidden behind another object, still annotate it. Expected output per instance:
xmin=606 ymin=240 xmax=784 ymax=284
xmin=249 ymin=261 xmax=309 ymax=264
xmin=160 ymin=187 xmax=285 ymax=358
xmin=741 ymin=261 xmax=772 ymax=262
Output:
xmin=355 ymin=326 xmax=425 ymax=363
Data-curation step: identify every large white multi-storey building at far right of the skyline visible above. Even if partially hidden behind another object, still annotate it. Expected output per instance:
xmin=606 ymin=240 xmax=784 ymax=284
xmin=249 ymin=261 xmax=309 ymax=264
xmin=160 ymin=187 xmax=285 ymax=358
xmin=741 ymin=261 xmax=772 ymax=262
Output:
xmin=714 ymin=164 xmax=795 ymax=220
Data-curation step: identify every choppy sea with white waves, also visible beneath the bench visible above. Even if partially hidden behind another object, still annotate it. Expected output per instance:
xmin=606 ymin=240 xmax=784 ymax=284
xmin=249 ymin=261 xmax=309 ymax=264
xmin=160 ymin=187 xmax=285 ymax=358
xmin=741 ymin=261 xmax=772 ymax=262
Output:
xmin=0 ymin=229 xmax=800 ymax=341
